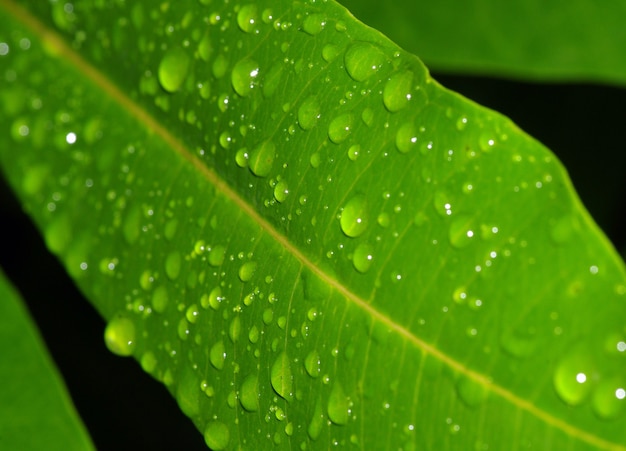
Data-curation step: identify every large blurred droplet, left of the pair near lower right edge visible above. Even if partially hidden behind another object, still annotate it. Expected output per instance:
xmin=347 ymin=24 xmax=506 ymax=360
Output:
xmin=553 ymin=348 xmax=596 ymax=406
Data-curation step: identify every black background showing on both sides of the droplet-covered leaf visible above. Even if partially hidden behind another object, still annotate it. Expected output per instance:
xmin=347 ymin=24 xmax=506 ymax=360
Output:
xmin=0 ymin=73 xmax=626 ymax=450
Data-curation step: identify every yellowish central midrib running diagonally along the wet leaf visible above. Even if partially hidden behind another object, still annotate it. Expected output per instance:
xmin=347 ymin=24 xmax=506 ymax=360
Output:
xmin=0 ymin=0 xmax=626 ymax=451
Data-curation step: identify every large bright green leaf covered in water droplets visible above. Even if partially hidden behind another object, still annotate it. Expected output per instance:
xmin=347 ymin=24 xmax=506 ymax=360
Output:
xmin=0 ymin=0 xmax=626 ymax=450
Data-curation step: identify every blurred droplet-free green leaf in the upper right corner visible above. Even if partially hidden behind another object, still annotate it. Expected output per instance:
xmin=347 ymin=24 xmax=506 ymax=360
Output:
xmin=340 ymin=0 xmax=626 ymax=86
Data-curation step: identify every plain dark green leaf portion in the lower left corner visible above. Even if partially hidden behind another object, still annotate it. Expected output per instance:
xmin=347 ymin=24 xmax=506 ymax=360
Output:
xmin=0 ymin=271 xmax=94 ymax=450
